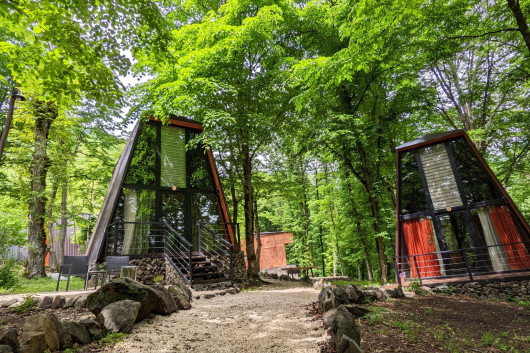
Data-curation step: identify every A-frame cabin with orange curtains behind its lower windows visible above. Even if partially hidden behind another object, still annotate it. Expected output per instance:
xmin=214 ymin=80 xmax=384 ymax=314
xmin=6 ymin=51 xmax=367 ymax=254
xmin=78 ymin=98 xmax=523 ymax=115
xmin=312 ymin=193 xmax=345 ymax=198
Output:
xmin=395 ymin=130 xmax=530 ymax=282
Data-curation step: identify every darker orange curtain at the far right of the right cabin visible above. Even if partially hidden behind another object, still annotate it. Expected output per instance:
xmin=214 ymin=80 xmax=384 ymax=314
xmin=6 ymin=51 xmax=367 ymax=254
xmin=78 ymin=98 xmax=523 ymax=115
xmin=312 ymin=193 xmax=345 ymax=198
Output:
xmin=489 ymin=206 xmax=530 ymax=270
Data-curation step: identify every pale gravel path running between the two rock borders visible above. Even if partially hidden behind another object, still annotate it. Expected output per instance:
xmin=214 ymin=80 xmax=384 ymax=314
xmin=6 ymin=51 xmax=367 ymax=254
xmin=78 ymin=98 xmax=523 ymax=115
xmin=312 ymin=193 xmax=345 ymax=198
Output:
xmin=99 ymin=282 xmax=325 ymax=353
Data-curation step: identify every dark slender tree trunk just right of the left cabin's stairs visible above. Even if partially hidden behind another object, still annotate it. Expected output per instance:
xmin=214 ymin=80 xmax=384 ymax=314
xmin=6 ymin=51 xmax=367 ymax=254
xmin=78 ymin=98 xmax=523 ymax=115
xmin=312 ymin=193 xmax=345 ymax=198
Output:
xmin=241 ymin=143 xmax=259 ymax=279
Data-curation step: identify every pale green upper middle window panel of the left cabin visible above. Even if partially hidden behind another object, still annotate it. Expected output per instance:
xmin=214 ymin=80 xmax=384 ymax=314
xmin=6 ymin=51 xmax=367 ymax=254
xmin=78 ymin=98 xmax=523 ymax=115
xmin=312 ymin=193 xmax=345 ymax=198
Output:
xmin=160 ymin=126 xmax=186 ymax=188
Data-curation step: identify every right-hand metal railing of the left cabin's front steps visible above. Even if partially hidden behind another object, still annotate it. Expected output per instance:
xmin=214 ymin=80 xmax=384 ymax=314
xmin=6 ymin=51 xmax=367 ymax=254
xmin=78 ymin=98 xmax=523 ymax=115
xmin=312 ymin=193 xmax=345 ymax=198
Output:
xmin=198 ymin=223 xmax=234 ymax=280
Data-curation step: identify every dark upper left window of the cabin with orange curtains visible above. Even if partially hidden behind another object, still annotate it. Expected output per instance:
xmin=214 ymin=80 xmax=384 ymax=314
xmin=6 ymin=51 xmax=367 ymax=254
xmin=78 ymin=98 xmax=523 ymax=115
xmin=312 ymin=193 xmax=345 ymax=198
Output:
xmin=401 ymin=152 xmax=429 ymax=215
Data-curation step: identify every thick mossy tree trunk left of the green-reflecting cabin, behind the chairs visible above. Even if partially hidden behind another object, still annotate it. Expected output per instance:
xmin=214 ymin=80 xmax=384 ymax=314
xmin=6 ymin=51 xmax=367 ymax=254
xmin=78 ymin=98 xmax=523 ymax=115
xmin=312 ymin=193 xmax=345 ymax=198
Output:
xmin=27 ymin=101 xmax=58 ymax=278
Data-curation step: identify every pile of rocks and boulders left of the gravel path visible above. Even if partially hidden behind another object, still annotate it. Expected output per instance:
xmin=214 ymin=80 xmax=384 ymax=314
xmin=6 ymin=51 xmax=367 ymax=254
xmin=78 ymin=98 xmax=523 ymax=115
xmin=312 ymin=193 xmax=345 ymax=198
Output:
xmin=0 ymin=278 xmax=191 ymax=353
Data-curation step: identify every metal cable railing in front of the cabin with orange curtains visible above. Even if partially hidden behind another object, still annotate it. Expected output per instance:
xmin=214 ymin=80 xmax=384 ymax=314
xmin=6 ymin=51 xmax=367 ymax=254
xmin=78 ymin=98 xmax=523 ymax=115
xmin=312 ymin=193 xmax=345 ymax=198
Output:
xmin=394 ymin=242 xmax=530 ymax=285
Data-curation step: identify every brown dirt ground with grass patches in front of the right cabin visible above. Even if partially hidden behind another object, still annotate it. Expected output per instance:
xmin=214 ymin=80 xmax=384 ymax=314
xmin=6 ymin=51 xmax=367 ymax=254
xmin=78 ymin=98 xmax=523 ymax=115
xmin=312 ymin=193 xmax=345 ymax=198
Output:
xmin=354 ymin=294 xmax=530 ymax=353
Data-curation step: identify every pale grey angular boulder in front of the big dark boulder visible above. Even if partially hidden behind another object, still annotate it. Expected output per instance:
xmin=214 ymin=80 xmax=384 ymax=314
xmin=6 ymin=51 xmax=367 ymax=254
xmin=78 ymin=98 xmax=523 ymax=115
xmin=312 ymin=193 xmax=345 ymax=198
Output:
xmin=98 ymin=300 xmax=141 ymax=333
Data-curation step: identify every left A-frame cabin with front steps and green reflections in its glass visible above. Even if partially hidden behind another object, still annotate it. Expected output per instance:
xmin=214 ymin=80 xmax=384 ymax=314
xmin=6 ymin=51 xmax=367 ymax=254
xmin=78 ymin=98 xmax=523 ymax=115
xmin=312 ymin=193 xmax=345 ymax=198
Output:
xmin=87 ymin=118 xmax=239 ymax=285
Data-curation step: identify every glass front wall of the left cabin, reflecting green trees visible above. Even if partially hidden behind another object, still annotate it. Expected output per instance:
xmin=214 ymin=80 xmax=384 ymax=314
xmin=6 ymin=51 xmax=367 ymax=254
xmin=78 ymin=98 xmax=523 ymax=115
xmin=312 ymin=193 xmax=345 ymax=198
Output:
xmin=105 ymin=121 xmax=224 ymax=255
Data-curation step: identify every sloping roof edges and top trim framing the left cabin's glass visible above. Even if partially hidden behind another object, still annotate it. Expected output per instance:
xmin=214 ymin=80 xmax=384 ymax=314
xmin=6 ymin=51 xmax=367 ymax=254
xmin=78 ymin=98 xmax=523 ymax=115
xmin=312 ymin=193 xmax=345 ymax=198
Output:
xmin=86 ymin=116 xmax=235 ymax=263
